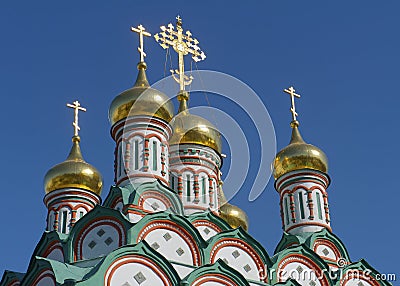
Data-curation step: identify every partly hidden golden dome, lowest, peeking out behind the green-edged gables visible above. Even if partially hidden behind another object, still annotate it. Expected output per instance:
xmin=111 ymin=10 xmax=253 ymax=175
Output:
xmin=219 ymin=188 xmax=249 ymax=231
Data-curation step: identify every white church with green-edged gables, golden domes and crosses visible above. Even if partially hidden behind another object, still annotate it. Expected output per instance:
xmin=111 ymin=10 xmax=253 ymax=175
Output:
xmin=0 ymin=17 xmax=391 ymax=286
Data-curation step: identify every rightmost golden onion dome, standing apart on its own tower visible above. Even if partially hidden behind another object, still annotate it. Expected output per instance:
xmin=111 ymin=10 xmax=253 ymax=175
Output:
xmin=273 ymin=121 xmax=328 ymax=179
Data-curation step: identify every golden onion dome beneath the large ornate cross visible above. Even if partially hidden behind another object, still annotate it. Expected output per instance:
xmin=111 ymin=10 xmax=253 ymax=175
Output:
xmin=169 ymin=92 xmax=222 ymax=154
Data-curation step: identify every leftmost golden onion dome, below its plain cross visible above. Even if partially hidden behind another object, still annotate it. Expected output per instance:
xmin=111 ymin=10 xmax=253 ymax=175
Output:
xmin=44 ymin=136 xmax=103 ymax=195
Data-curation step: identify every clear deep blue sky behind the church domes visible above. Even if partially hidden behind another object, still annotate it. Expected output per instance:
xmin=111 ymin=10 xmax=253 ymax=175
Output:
xmin=0 ymin=0 xmax=400 ymax=278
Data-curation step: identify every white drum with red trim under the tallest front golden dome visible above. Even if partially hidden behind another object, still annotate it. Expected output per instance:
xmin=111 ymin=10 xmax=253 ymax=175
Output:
xmin=111 ymin=116 xmax=172 ymax=186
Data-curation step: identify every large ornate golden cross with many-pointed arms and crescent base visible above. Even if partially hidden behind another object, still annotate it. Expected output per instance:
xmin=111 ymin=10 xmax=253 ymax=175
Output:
xmin=154 ymin=16 xmax=206 ymax=91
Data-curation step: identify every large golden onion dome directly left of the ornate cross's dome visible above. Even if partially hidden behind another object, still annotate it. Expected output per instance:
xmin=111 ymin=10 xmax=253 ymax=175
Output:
xmin=108 ymin=62 xmax=174 ymax=125
